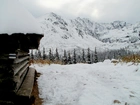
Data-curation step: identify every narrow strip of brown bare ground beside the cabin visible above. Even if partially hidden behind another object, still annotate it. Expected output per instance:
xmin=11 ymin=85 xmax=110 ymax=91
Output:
xmin=32 ymin=73 xmax=42 ymax=105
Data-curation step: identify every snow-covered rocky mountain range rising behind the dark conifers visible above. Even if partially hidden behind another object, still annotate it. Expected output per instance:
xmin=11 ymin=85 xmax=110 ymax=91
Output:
xmin=38 ymin=13 xmax=140 ymax=51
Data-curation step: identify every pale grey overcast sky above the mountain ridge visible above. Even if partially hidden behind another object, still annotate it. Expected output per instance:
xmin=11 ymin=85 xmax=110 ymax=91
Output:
xmin=19 ymin=0 xmax=140 ymax=23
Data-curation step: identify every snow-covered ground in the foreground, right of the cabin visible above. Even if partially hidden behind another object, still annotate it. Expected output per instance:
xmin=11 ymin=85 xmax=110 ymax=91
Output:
xmin=31 ymin=60 xmax=140 ymax=105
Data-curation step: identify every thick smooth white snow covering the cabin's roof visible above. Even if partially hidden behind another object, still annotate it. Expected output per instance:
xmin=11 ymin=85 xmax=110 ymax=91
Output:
xmin=0 ymin=0 xmax=42 ymax=35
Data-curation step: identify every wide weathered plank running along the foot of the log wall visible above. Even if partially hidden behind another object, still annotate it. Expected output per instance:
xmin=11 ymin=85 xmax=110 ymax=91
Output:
xmin=17 ymin=68 xmax=35 ymax=99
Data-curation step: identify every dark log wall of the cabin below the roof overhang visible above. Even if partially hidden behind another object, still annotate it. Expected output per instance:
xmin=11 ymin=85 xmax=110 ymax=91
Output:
xmin=0 ymin=50 xmax=29 ymax=105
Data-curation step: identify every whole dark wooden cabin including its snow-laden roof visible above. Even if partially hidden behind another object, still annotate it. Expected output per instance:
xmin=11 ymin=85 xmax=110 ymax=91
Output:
xmin=0 ymin=0 xmax=43 ymax=105
